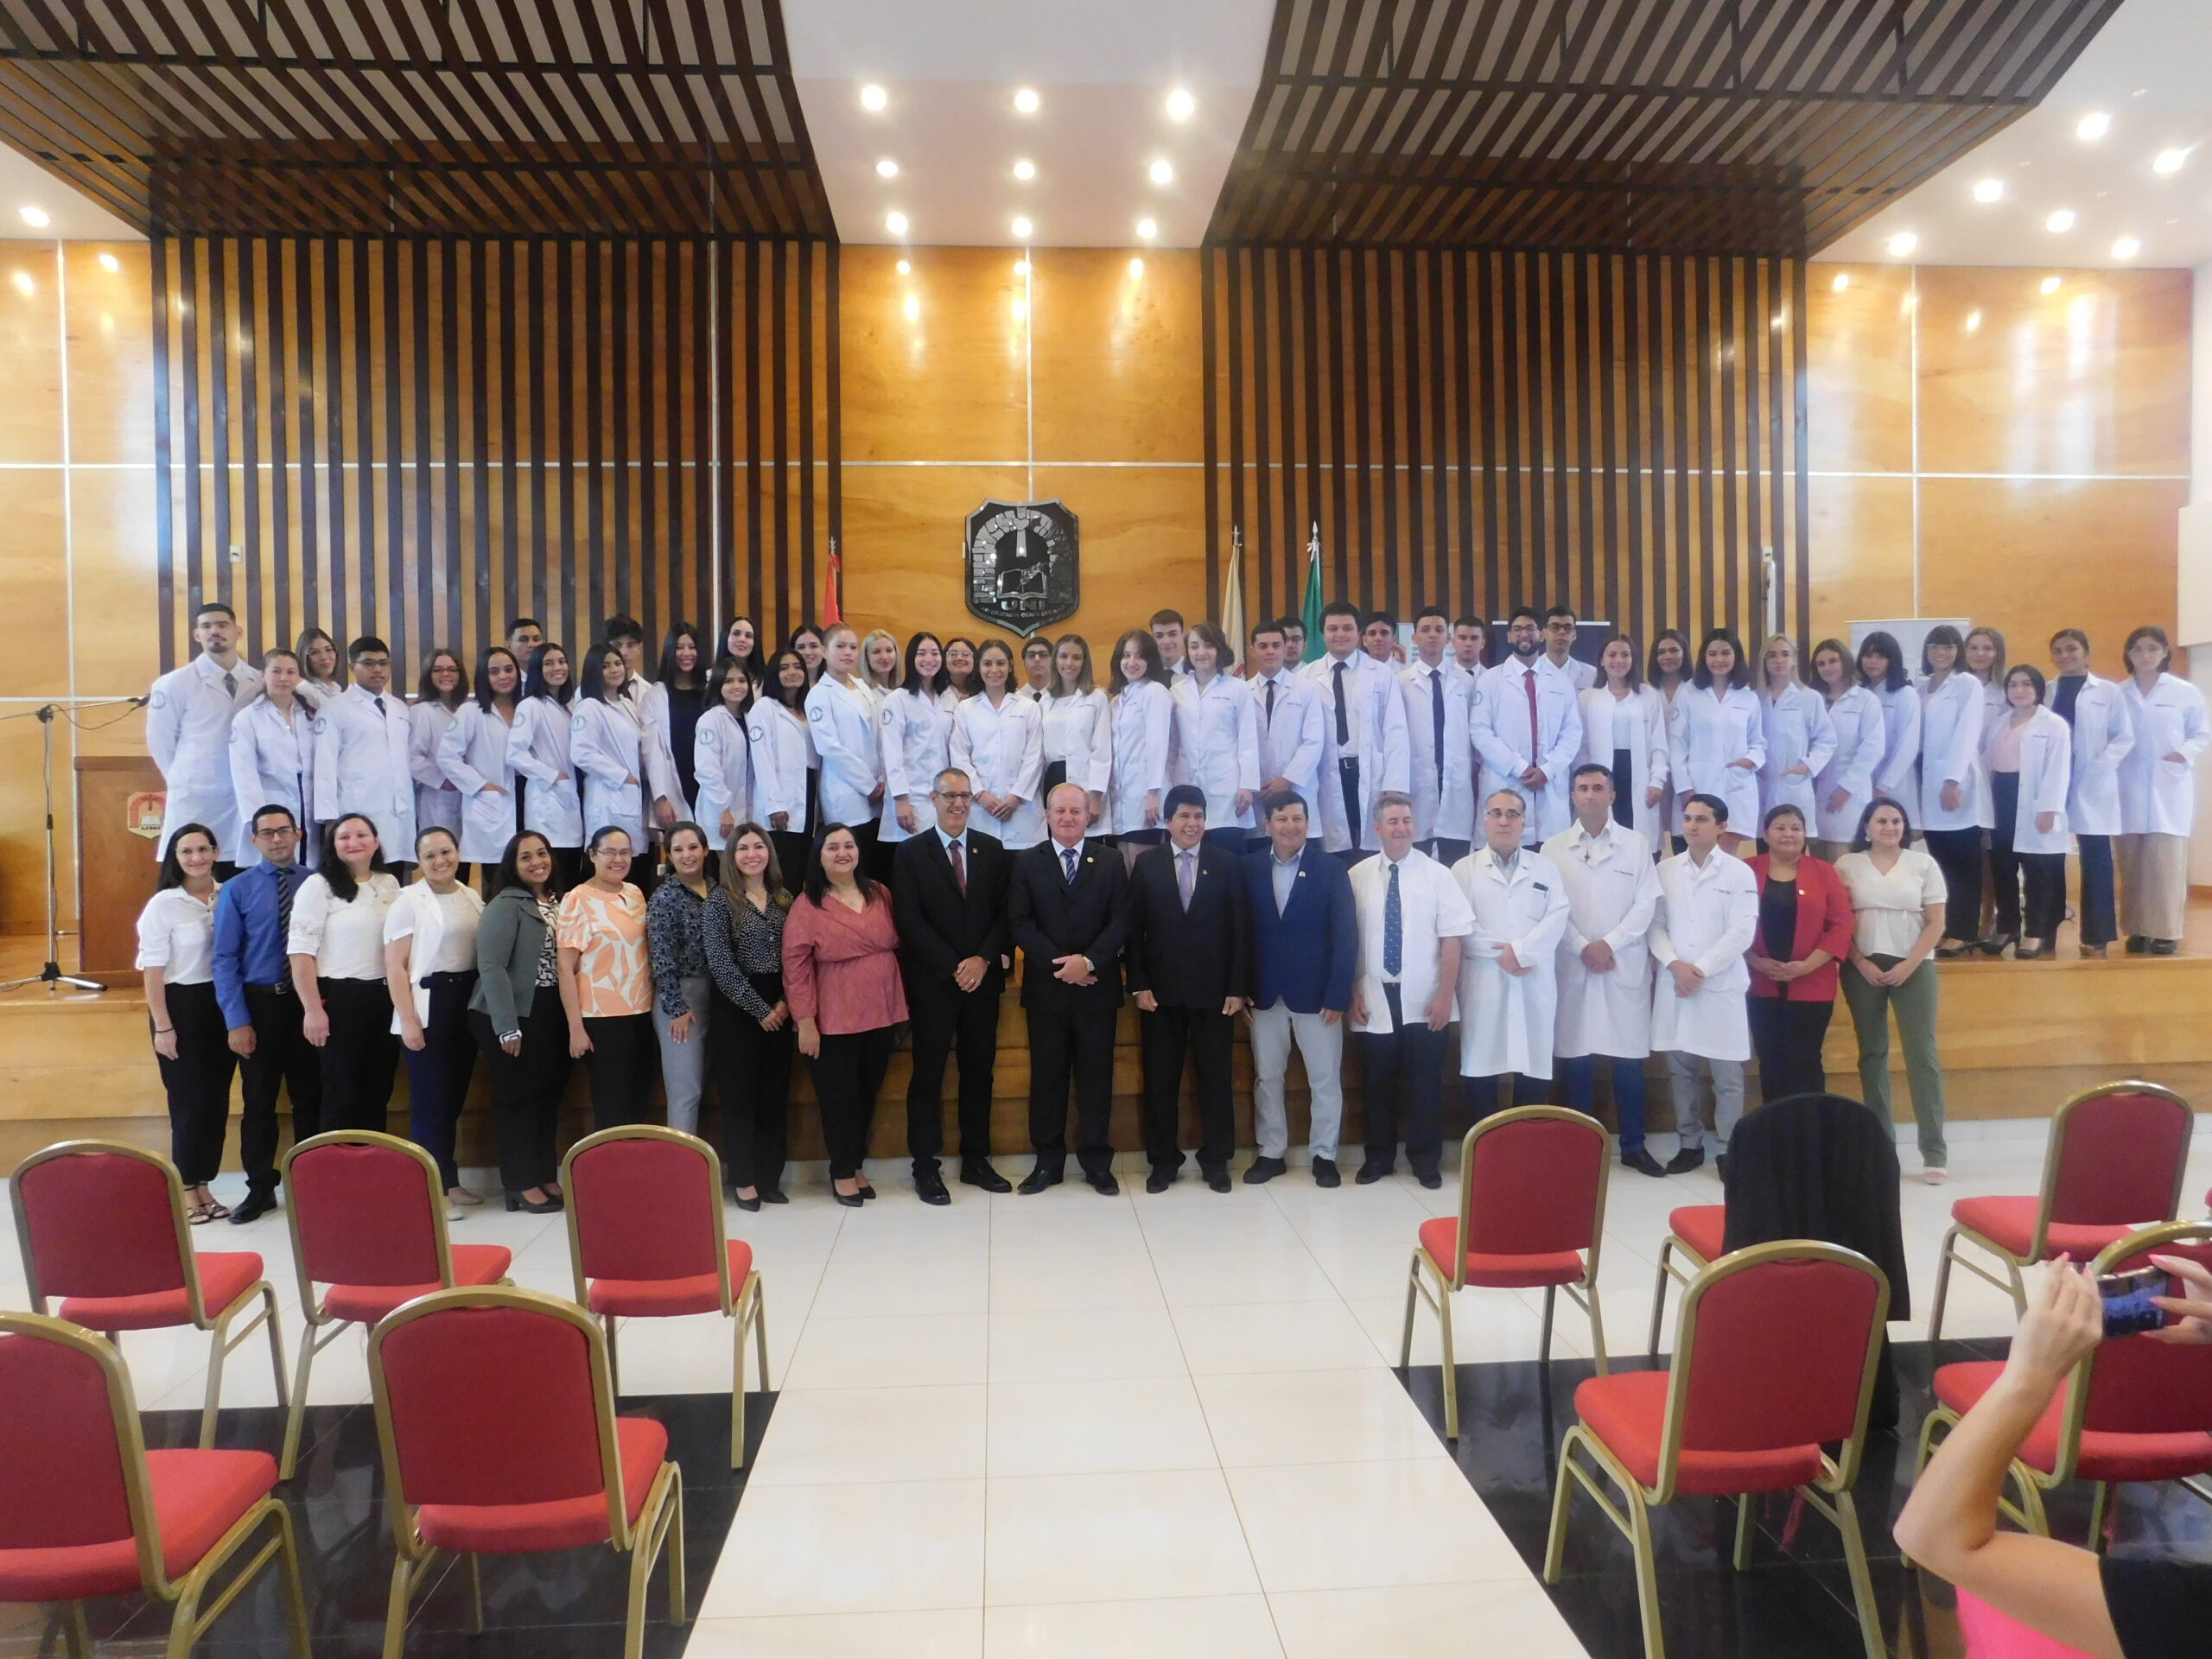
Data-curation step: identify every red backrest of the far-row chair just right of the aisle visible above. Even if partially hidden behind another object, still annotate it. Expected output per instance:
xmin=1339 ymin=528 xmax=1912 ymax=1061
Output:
xmin=1458 ymin=1106 xmax=1612 ymax=1274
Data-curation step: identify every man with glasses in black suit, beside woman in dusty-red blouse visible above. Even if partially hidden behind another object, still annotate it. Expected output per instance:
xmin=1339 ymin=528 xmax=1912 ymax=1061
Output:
xmin=892 ymin=767 xmax=1013 ymax=1204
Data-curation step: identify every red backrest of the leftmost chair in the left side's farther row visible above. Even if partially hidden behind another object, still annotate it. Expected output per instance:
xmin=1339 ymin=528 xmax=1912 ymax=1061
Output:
xmin=9 ymin=1141 xmax=201 ymax=1320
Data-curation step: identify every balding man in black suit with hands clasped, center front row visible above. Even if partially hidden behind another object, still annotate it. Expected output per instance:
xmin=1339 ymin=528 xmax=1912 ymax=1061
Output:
xmin=1007 ymin=783 xmax=1128 ymax=1194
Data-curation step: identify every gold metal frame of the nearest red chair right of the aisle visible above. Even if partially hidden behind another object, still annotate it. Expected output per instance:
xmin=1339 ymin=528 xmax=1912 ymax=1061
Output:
xmin=1544 ymin=1239 xmax=1889 ymax=1659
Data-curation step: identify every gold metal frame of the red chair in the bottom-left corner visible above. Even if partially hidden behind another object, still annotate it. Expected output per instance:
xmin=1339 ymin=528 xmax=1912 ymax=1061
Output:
xmin=0 ymin=1314 xmax=309 ymax=1659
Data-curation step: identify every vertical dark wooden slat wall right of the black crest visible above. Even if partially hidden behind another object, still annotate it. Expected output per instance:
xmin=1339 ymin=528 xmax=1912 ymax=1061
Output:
xmin=1204 ymin=245 xmax=1812 ymax=641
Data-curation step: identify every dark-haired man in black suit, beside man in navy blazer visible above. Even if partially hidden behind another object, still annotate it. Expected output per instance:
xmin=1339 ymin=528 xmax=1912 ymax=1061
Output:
xmin=1128 ymin=783 xmax=1249 ymax=1192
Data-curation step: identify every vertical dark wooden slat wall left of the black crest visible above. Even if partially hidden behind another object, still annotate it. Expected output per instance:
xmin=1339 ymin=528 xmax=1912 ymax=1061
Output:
xmin=153 ymin=237 xmax=841 ymax=688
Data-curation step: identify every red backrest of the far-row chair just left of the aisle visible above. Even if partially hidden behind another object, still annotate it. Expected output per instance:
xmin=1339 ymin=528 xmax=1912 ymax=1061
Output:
xmin=562 ymin=1123 xmax=730 ymax=1303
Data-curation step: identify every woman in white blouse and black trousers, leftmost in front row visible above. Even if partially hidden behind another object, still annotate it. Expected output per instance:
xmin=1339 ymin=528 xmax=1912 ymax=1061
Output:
xmin=137 ymin=827 xmax=235 ymax=1228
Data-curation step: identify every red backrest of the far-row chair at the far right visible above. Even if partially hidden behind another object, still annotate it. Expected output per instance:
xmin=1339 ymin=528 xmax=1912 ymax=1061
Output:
xmin=2037 ymin=1082 xmax=2195 ymax=1243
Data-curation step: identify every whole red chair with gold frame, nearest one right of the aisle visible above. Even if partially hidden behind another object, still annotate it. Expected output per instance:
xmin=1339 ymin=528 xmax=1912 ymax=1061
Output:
xmin=1544 ymin=1239 xmax=1889 ymax=1659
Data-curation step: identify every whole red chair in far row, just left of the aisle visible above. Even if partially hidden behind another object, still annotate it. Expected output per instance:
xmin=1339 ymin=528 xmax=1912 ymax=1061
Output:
xmin=560 ymin=1123 xmax=767 ymax=1469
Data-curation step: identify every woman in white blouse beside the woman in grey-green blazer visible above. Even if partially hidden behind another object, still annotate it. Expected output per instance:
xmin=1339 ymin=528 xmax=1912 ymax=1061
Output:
xmin=385 ymin=827 xmax=484 ymax=1221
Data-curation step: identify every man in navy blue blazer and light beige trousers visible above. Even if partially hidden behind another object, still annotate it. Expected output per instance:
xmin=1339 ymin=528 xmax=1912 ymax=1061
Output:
xmin=1243 ymin=790 xmax=1360 ymax=1185
